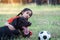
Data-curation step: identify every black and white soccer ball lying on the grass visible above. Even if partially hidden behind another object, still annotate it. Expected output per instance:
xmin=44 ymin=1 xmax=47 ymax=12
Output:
xmin=38 ymin=31 xmax=51 ymax=40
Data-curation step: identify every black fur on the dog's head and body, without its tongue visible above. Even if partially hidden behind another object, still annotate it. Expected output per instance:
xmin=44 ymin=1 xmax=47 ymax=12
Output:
xmin=0 ymin=17 xmax=31 ymax=40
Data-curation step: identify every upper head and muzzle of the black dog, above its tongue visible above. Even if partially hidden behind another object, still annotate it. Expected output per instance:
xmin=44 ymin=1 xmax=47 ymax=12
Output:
xmin=11 ymin=17 xmax=31 ymax=29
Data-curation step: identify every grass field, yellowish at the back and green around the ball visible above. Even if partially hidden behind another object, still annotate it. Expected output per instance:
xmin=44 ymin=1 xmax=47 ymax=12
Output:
xmin=0 ymin=4 xmax=60 ymax=40
